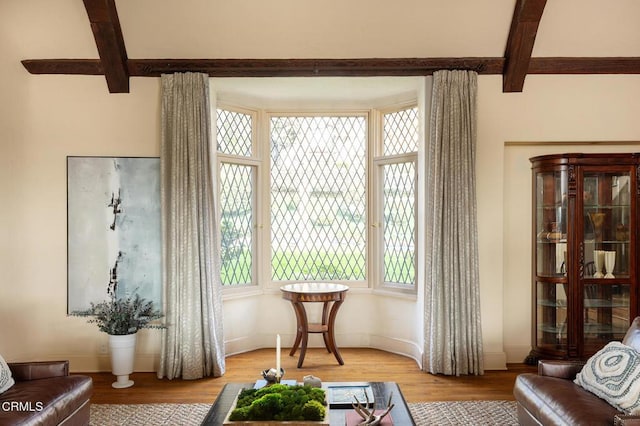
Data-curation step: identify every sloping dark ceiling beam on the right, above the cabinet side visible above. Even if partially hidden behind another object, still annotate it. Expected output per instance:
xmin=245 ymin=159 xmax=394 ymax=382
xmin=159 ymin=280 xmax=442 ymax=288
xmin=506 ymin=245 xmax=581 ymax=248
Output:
xmin=502 ymin=0 xmax=547 ymax=92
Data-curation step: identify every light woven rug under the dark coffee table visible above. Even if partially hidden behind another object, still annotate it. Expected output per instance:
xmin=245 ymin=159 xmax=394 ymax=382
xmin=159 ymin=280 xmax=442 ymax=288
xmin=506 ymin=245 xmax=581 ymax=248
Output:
xmin=90 ymin=401 xmax=518 ymax=426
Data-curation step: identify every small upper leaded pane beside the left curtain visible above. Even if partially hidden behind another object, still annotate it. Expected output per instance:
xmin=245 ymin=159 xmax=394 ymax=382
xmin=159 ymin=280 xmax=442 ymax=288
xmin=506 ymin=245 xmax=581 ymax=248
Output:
xmin=217 ymin=109 xmax=251 ymax=157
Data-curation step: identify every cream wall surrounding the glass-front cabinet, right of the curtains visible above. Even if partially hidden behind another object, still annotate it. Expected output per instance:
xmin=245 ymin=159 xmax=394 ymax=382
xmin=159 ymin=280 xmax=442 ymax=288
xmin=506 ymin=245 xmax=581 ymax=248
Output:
xmin=478 ymin=76 xmax=640 ymax=362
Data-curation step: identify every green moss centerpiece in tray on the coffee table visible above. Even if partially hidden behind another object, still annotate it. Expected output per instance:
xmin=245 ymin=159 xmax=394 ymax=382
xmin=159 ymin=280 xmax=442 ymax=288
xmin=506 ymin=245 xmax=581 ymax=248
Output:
xmin=225 ymin=384 xmax=327 ymax=424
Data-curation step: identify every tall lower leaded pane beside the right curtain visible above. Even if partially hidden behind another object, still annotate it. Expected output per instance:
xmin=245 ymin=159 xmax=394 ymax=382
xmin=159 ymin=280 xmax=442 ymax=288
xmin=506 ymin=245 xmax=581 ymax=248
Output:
xmin=382 ymin=162 xmax=415 ymax=285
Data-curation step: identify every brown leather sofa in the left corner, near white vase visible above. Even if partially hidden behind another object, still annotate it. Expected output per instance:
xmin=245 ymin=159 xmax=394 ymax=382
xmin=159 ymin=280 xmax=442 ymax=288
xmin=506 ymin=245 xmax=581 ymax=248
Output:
xmin=0 ymin=361 xmax=93 ymax=426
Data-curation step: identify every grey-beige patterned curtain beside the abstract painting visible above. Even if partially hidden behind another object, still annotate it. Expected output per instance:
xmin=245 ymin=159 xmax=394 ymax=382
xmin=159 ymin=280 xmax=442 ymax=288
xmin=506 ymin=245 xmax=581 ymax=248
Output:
xmin=158 ymin=73 xmax=225 ymax=379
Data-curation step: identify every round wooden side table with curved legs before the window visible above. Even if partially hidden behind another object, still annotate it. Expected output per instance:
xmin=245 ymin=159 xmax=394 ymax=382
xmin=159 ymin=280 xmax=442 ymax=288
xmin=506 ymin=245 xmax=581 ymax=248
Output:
xmin=280 ymin=283 xmax=349 ymax=368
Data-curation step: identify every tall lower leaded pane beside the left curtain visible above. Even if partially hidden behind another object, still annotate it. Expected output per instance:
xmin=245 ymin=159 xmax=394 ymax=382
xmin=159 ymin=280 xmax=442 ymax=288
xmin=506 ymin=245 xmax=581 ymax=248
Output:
xmin=220 ymin=163 xmax=254 ymax=285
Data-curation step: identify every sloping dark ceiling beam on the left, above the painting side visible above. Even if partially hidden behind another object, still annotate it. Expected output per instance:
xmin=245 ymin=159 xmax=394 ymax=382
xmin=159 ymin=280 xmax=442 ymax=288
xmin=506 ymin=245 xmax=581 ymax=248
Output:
xmin=82 ymin=0 xmax=129 ymax=93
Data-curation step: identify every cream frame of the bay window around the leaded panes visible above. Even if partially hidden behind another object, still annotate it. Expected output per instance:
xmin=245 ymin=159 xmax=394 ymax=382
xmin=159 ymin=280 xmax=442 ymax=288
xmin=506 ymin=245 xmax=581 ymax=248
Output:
xmin=216 ymin=99 xmax=419 ymax=298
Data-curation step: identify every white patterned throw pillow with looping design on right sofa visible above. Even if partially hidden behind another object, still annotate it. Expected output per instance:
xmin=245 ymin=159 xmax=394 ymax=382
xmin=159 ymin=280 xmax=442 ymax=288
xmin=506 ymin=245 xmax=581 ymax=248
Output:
xmin=575 ymin=342 xmax=640 ymax=414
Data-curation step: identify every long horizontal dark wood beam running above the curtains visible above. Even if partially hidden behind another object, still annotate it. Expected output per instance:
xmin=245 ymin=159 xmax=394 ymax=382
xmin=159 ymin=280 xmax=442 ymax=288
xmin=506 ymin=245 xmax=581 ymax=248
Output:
xmin=22 ymin=57 xmax=640 ymax=77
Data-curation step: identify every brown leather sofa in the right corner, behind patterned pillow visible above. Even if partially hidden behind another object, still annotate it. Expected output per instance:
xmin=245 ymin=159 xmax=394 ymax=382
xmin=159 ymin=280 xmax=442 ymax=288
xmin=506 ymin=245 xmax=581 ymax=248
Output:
xmin=513 ymin=317 xmax=640 ymax=426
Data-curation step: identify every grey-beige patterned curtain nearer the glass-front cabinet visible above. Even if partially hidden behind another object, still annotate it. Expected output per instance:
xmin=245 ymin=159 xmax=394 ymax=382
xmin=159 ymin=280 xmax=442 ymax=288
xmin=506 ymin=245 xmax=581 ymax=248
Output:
xmin=422 ymin=71 xmax=484 ymax=376
